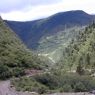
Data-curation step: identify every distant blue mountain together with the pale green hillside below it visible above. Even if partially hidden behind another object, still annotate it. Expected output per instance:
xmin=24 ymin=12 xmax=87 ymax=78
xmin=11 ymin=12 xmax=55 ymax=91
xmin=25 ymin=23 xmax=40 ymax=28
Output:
xmin=5 ymin=10 xmax=95 ymax=62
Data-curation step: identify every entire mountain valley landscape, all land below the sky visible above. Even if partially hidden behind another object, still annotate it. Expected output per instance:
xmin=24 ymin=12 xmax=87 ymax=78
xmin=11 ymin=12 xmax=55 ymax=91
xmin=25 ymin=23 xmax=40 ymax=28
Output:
xmin=0 ymin=10 xmax=95 ymax=95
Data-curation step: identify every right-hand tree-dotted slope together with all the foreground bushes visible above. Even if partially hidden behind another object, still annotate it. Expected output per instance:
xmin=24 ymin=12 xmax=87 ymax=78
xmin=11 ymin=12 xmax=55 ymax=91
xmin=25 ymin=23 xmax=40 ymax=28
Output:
xmin=12 ymin=23 xmax=95 ymax=93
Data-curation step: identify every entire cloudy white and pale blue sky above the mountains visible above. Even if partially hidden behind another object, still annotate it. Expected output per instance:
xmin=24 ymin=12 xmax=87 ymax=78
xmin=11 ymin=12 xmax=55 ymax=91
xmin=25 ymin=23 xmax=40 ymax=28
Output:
xmin=0 ymin=0 xmax=95 ymax=21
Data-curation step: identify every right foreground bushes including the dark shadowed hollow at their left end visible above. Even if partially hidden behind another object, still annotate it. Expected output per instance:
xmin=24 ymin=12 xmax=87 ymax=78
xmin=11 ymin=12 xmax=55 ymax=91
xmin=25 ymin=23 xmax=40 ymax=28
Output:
xmin=35 ymin=73 xmax=95 ymax=92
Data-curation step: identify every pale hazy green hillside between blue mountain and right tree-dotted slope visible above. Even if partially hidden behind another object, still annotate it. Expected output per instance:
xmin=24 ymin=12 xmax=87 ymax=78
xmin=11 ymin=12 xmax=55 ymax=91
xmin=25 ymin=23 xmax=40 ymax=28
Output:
xmin=36 ymin=26 xmax=85 ymax=63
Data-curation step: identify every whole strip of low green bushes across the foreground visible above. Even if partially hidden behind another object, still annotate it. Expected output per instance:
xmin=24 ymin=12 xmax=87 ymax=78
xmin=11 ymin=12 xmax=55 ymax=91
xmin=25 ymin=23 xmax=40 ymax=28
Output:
xmin=12 ymin=73 xmax=95 ymax=94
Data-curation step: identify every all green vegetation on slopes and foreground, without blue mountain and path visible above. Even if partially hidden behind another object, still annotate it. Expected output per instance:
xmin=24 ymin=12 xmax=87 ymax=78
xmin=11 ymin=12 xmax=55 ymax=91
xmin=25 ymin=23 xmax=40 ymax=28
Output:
xmin=0 ymin=14 xmax=95 ymax=94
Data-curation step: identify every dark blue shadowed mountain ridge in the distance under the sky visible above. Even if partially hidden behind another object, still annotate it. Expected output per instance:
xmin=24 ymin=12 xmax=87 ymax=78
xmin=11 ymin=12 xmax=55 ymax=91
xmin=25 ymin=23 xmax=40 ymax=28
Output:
xmin=6 ymin=10 xmax=95 ymax=49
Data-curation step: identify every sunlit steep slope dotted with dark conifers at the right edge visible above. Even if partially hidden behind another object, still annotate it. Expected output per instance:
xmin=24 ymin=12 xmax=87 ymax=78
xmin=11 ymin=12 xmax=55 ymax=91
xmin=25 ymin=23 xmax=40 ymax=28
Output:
xmin=59 ymin=23 xmax=95 ymax=73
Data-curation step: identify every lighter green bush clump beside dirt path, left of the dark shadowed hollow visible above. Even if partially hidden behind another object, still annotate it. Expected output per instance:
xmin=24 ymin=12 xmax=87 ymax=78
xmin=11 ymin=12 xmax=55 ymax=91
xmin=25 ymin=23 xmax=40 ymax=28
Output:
xmin=12 ymin=77 xmax=48 ymax=94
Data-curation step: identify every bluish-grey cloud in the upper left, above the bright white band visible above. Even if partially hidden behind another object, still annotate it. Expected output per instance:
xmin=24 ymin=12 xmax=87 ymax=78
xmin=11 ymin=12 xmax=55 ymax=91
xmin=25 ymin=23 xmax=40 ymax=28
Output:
xmin=0 ymin=0 xmax=62 ymax=13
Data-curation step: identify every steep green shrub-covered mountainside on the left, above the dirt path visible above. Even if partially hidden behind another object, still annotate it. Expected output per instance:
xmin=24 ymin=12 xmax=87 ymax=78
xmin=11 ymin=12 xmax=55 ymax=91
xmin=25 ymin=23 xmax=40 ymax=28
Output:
xmin=0 ymin=17 xmax=44 ymax=79
